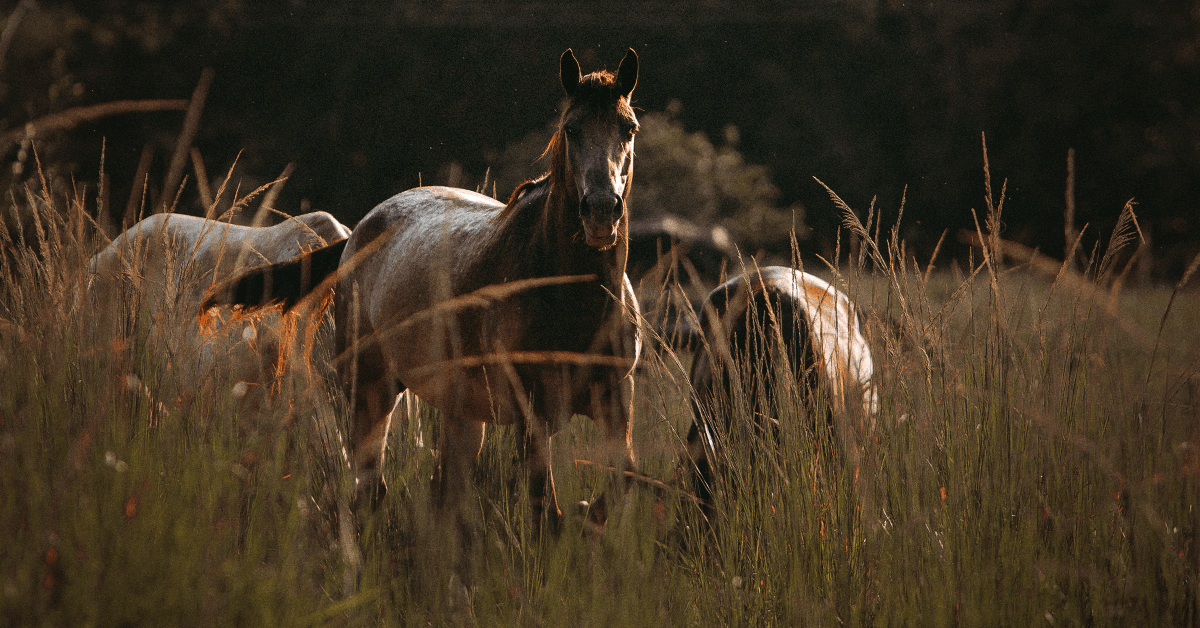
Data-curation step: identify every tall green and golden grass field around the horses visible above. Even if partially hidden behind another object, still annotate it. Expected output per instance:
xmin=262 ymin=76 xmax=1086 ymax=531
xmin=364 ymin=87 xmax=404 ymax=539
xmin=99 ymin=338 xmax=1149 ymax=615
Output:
xmin=0 ymin=172 xmax=1200 ymax=627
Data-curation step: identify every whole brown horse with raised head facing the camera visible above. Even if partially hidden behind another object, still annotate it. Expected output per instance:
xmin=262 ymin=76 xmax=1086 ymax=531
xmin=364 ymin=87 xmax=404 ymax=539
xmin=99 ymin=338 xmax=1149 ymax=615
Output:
xmin=209 ymin=49 xmax=641 ymax=527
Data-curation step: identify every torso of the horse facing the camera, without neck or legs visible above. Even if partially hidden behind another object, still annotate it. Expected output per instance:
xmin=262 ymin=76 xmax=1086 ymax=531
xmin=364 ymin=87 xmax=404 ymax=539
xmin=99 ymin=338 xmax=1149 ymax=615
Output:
xmin=336 ymin=186 xmax=637 ymax=421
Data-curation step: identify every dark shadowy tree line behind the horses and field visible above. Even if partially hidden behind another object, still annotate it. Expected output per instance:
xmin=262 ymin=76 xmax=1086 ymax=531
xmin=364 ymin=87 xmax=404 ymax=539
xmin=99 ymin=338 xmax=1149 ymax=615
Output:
xmin=0 ymin=0 xmax=1200 ymax=277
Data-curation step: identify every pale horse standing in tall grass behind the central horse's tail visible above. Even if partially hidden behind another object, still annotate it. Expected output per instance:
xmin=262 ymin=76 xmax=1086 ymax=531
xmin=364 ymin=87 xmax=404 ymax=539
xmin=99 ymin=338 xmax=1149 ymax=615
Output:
xmin=88 ymin=211 xmax=350 ymax=415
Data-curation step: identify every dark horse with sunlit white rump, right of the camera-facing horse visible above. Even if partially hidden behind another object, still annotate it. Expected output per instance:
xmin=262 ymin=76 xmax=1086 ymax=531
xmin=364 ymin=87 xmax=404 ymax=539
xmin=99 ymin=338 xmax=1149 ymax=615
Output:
xmin=688 ymin=267 xmax=878 ymax=515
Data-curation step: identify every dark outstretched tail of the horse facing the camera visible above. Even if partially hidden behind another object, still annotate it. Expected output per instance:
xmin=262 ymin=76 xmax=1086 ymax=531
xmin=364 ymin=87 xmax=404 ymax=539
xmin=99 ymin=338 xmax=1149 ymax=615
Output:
xmin=200 ymin=240 xmax=349 ymax=312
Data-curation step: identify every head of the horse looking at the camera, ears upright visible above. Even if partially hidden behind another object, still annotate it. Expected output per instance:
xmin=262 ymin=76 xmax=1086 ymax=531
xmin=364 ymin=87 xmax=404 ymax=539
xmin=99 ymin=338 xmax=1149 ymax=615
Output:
xmin=554 ymin=48 xmax=638 ymax=249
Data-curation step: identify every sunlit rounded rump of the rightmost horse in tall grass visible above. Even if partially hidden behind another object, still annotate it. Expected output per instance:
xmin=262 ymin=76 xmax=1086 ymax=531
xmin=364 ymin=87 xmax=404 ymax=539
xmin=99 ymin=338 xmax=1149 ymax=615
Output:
xmin=686 ymin=267 xmax=878 ymax=520
